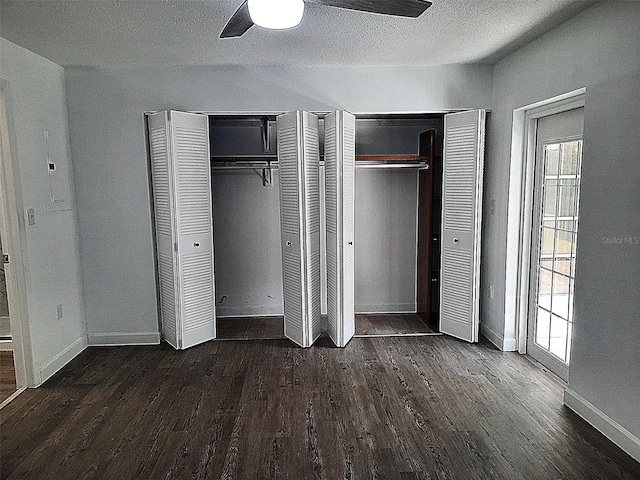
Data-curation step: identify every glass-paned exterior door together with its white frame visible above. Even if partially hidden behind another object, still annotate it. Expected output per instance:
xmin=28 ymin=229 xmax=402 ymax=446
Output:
xmin=505 ymin=94 xmax=585 ymax=380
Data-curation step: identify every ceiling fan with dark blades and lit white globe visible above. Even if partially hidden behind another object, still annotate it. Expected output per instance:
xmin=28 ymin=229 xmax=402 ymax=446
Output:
xmin=220 ymin=0 xmax=431 ymax=38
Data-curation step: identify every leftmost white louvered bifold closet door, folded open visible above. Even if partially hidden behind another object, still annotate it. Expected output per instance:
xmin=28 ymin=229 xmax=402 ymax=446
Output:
xmin=149 ymin=111 xmax=216 ymax=349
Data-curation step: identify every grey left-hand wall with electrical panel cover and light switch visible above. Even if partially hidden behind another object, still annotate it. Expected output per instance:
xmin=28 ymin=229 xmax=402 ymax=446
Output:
xmin=0 ymin=38 xmax=87 ymax=384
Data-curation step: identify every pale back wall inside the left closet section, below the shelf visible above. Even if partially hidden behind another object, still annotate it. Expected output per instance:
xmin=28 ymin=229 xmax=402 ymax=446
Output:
xmin=211 ymin=169 xmax=284 ymax=317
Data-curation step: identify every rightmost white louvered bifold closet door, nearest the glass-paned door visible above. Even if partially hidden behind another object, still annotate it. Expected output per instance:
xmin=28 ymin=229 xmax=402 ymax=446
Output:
xmin=440 ymin=110 xmax=485 ymax=342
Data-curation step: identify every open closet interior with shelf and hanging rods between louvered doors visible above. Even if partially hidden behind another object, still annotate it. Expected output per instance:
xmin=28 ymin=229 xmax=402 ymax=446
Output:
xmin=209 ymin=113 xmax=444 ymax=339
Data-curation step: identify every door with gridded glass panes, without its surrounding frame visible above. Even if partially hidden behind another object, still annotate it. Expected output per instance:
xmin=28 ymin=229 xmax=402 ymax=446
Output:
xmin=527 ymin=108 xmax=584 ymax=381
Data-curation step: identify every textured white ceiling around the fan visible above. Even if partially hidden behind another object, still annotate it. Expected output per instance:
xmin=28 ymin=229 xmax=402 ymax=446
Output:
xmin=0 ymin=0 xmax=594 ymax=66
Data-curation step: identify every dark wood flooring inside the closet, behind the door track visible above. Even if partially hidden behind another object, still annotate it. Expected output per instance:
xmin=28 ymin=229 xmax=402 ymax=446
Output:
xmin=216 ymin=313 xmax=433 ymax=340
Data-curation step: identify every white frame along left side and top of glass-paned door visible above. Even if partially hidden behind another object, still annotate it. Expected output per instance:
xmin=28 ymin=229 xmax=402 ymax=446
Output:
xmin=505 ymin=88 xmax=586 ymax=354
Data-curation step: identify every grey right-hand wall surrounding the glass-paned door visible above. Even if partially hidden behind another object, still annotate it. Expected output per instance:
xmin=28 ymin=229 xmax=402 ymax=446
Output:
xmin=482 ymin=2 xmax=640 ymax=458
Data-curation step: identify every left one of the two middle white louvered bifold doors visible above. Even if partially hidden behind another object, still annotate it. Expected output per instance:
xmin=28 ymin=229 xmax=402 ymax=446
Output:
xmin=277 ymin=111 xmax=321 ymax=347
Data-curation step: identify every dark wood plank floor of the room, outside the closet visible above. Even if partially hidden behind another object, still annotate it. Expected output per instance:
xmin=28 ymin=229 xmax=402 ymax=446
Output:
xmin=0 ymin=336 xmax=640 ymax=480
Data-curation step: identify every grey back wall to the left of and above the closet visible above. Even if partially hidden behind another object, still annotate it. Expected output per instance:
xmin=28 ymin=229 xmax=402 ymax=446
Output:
xmin=65 ymin=65 xmax=491 ymax=342
